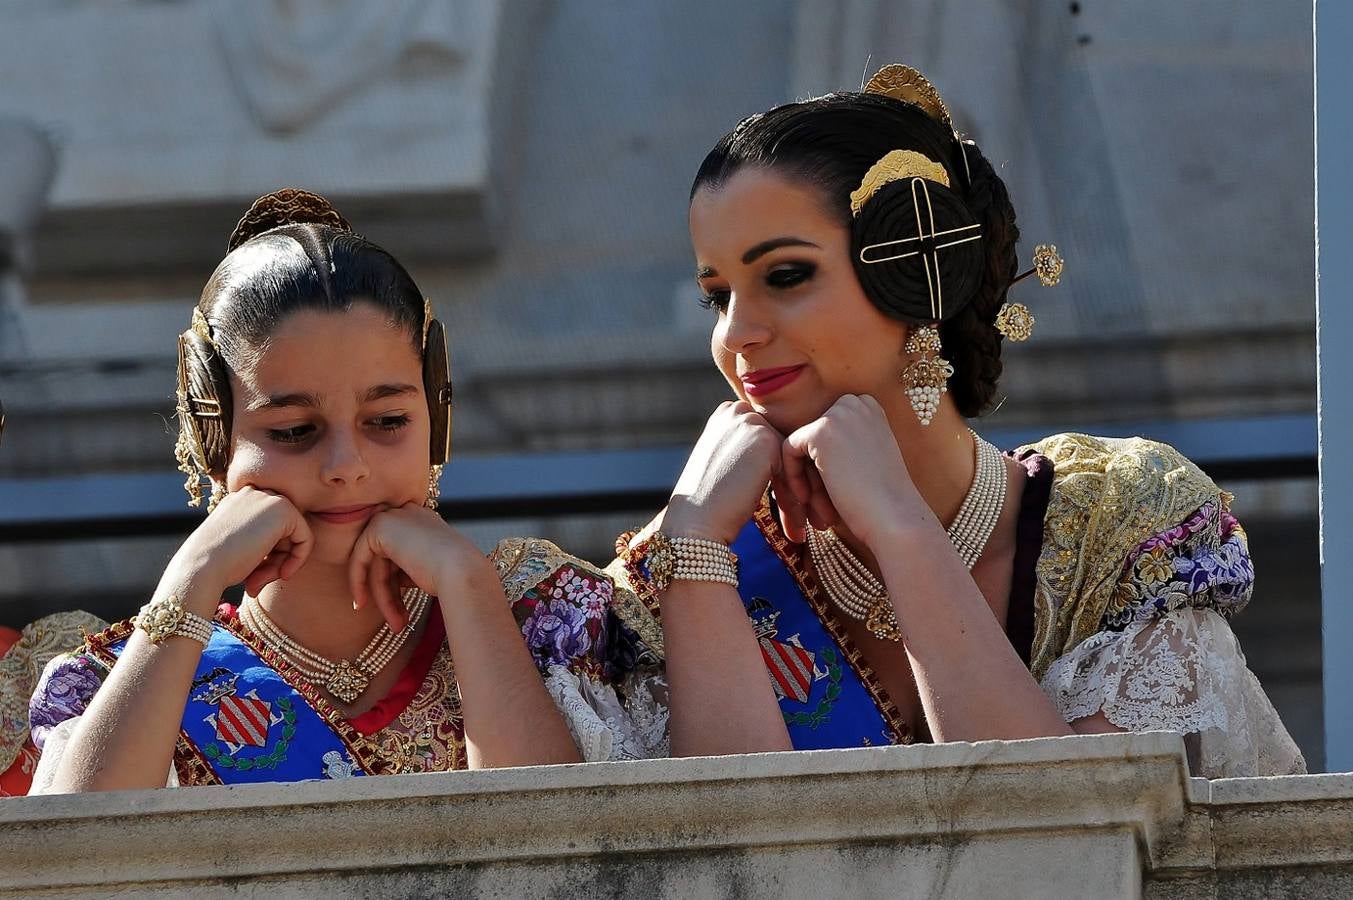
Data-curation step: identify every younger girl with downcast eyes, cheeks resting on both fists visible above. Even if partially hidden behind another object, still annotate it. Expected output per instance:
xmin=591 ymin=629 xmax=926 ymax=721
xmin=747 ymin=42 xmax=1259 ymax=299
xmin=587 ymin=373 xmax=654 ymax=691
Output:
xmin=30 ymin=189 xmax=619 ymax=792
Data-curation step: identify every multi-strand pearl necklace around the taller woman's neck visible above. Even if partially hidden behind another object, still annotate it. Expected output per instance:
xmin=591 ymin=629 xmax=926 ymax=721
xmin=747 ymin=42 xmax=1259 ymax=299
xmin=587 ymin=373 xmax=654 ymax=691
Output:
xmin=808 ymin=432 xmax=1008 ymax=642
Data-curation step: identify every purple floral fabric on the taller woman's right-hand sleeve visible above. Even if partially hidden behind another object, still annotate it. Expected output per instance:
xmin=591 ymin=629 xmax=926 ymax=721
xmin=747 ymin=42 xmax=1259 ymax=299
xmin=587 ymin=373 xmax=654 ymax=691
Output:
xmin=1105 ymin=503 xmax=1254 ymax=629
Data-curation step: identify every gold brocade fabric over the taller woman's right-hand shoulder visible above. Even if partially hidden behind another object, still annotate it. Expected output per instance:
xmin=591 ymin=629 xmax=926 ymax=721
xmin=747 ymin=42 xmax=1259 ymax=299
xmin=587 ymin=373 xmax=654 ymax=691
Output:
xmin=1020 ymin=434 xmax=1231 ymax=679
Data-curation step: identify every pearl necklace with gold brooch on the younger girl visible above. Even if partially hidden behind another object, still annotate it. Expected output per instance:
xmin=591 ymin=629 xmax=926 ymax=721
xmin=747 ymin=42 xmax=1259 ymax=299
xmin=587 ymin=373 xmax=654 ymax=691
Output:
xmin=239 ymin=587 xmax=432 ymax=704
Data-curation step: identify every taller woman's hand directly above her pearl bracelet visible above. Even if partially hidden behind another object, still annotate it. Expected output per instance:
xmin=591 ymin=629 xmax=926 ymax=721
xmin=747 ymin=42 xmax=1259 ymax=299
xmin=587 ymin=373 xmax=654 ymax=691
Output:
xmin=660 ymin=401 xmax=787 ymax=544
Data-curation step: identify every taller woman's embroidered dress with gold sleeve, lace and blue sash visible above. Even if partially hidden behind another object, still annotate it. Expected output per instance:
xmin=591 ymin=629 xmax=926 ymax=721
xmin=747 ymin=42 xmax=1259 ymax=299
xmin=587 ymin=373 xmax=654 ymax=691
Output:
xmin=607 ymin=434 xmax=1306 ymax=778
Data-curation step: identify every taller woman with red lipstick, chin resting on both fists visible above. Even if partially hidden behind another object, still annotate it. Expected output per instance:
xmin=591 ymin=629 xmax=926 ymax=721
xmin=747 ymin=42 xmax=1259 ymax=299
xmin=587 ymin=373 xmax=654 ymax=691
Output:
xmin=600 ymin=66 xmax=1304 ymax=777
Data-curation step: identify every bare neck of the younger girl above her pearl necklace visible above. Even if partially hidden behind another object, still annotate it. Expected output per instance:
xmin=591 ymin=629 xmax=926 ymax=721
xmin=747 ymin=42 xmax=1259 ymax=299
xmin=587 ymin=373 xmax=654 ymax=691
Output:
xmin=249 ymin=559 xmax=384 ymax=662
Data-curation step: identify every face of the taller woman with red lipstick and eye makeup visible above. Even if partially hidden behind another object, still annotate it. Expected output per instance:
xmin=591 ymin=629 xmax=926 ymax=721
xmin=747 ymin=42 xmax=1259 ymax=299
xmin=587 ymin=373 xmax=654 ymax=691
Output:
xmin=690 ymin=168 xmax=907 ymax=434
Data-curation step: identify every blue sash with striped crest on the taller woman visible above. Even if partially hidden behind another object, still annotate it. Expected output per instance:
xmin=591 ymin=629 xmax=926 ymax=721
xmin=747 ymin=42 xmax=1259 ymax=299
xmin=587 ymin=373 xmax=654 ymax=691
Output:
xmin=732 ymin=509 xmax=897 ymax=750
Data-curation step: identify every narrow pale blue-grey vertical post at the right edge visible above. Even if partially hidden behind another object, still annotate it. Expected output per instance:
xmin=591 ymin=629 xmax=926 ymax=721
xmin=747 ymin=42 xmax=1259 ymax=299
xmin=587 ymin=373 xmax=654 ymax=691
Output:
xmin=1315 ymin=0 xmax=1353 ymax=771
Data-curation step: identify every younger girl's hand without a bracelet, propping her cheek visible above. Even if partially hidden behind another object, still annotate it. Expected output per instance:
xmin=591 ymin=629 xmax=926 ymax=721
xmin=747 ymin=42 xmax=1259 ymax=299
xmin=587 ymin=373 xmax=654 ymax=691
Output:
xmin=348 ymin=502 xmax=506 ymax=631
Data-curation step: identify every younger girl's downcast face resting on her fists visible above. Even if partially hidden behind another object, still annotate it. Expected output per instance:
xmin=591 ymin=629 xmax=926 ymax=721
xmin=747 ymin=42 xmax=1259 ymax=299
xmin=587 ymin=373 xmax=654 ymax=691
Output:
xmin=226 ymin=303 xmax=430 ymax=563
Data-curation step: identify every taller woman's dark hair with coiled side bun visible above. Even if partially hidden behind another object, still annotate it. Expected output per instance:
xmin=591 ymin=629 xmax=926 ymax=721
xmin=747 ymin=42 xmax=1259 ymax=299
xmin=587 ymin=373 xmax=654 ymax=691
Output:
xmin=691 ymin=92 xmax=1019 ymax=417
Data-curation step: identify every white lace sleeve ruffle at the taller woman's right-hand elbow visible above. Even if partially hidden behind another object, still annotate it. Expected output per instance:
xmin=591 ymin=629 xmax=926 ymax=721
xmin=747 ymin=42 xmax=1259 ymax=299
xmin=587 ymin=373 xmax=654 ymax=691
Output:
xmin=1042 ymin=608 xmax=1306 ymax=778
